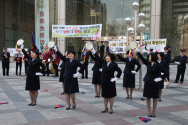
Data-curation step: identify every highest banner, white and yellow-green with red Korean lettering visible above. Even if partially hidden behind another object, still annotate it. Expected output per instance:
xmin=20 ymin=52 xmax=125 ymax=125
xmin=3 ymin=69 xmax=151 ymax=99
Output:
xmin=52 ymin=24 xmax=102 ymax=37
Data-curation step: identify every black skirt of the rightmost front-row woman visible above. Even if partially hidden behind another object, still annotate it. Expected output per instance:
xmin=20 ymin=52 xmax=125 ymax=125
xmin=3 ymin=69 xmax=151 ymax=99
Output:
xmin=143 ymin=83 xmax=159 ymax=98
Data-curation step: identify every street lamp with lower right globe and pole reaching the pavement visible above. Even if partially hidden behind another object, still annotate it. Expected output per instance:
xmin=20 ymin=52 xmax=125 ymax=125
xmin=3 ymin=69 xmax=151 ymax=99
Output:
xmin=138 ymin=23 xmax=145 ymax=91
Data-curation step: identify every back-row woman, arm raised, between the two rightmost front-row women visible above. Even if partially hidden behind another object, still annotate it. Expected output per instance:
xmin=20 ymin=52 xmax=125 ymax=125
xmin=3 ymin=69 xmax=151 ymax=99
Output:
xmin=117 ymin=50 xmax=141 ymax=99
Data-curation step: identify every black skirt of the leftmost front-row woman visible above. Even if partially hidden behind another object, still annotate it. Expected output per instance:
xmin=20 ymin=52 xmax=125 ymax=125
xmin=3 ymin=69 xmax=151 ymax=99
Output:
xmin=25 ymin=75 xmax=40 ymax=90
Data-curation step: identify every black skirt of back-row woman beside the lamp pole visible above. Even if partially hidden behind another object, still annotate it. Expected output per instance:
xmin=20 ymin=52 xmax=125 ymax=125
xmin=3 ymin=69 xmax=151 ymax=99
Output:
xmin=123 ymin=74 xmax=135 ymax=88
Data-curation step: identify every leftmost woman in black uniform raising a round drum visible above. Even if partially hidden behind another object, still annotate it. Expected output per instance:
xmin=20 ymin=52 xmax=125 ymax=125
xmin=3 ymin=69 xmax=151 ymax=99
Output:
xmin=21 ymin=45 xmax=45 ymax=106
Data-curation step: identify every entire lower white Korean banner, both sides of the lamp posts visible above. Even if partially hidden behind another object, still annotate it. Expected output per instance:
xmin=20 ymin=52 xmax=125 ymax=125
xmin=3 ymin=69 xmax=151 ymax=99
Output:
xmin=109 ymin=39 xmax=166 ymax=53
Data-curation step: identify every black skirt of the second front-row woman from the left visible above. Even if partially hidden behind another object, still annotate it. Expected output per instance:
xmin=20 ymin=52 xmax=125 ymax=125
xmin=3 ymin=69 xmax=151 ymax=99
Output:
xmin=64 ymin=78 xmax=79 ymax=94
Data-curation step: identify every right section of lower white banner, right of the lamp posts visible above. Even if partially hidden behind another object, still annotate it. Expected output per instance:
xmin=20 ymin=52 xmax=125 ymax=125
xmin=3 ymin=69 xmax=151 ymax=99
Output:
xmin=137 ymin=39 xmax=166 ymax=52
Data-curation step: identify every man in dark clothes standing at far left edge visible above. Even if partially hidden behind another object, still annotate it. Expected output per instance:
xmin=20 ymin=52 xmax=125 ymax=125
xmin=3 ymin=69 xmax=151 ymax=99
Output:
xmin=1 ymin=48 xmax=10 ymax=76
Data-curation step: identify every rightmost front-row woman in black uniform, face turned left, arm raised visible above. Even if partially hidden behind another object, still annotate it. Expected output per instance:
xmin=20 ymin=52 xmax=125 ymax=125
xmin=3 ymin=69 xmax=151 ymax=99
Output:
xmin=136 ymin=50 xmax=167 ymax=117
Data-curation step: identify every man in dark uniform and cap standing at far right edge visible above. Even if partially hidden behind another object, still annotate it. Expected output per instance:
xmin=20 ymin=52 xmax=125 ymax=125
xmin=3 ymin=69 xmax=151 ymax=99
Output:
xmin=174 ymin=49 xmax=187 ymax=83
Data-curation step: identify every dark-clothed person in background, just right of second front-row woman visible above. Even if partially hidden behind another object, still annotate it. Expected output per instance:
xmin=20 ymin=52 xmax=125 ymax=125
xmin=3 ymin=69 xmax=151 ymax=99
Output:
xmin=81 ymin=52 xmax=89 ymax=79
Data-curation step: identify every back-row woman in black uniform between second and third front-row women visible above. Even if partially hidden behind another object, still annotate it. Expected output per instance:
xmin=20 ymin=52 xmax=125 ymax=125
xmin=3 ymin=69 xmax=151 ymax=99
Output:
xmin=89 ymin=51 xmax=102 ymax=98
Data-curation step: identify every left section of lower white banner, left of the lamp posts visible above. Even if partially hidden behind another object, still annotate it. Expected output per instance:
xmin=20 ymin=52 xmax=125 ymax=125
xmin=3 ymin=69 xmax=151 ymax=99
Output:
xmin=109 ymin=41 xmax=127 ymax=53
